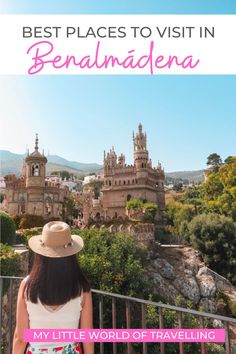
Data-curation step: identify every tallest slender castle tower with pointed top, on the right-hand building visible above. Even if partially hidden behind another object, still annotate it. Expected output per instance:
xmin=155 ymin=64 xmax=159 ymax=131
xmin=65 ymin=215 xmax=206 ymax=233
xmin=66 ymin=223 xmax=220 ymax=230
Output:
xmin=133 ymin=123 xmax=149 ymax=182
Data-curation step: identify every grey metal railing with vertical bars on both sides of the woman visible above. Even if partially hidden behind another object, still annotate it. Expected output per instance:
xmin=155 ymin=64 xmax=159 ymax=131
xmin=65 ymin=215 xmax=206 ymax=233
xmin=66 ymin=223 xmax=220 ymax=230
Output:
xmin=0 ymin=276 xmax=236 ymax=354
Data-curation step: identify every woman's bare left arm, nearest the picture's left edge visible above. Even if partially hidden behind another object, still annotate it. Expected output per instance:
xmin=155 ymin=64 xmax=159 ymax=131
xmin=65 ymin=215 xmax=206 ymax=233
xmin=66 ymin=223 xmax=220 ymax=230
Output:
xmin=12 ymin=280 xmax=29 ymax=354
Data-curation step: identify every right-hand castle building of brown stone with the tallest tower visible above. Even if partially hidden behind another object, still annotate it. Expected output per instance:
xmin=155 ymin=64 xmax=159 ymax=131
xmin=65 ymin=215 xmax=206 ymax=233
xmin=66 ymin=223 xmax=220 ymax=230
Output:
xmin=102 ymin=124 xmax=165 ymax=219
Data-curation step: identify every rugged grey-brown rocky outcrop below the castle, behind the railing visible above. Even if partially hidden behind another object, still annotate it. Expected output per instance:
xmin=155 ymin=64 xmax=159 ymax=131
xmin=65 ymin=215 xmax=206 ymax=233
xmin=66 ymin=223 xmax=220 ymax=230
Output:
xmin=145 ymin=246 xmax=236 ymax=313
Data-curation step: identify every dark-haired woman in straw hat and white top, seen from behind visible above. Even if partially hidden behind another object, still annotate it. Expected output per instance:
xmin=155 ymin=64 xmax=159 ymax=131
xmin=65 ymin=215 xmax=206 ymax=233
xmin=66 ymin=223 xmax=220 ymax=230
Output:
xmin=12 ymin=221 xmax=94 ymax=354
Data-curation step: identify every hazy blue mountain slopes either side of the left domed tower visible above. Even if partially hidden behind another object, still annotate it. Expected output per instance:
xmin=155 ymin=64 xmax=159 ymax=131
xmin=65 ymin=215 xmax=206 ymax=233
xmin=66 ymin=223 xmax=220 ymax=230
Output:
xmin=0 ymin=150 xmax=102 ymax=176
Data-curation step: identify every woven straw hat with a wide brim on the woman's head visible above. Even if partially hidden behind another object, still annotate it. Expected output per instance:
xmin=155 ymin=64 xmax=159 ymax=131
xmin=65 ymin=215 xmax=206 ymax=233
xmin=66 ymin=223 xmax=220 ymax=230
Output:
xmin=29 ymin=221 xmax=84 ymax=257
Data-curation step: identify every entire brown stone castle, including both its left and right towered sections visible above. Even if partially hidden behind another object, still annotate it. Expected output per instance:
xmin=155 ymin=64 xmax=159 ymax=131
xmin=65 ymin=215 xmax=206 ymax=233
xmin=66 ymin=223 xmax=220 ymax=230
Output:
xmin=4 ymin=124 xmax=165 ymax=225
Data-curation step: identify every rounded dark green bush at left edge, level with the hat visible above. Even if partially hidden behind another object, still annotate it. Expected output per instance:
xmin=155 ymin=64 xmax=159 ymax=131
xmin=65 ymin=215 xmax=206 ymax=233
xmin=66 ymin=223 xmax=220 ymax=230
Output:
xmin=0 ymin=211 xmax=16 ymax=245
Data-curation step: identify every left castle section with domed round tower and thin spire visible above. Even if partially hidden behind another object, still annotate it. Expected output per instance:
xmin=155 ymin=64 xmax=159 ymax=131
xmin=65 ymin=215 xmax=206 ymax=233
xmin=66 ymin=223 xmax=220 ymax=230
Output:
xmin=4 ymin=135 xmax=67 ymax=219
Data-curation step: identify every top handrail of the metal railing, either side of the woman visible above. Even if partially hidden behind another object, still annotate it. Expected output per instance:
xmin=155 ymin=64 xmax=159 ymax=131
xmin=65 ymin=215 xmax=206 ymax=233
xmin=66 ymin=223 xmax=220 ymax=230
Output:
xmin=0 ymin=276 xmax=236 ymax=324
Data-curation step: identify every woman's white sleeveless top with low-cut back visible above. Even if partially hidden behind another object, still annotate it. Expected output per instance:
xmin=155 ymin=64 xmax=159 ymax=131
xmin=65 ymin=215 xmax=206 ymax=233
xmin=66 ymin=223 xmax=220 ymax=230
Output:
xmin=25 ymin=276 xmax=83 ymax=348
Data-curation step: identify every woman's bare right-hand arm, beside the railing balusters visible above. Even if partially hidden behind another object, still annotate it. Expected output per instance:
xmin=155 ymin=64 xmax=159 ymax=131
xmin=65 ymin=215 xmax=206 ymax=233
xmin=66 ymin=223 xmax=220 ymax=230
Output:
xmin=80 ymin=291 xmax=94 ymax=354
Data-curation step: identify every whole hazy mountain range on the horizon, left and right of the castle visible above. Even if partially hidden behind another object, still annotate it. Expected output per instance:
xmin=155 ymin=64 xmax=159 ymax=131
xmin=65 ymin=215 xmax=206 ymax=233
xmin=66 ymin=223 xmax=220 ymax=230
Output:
xmin=0 ymin=150 xmax=204 ymax=183
